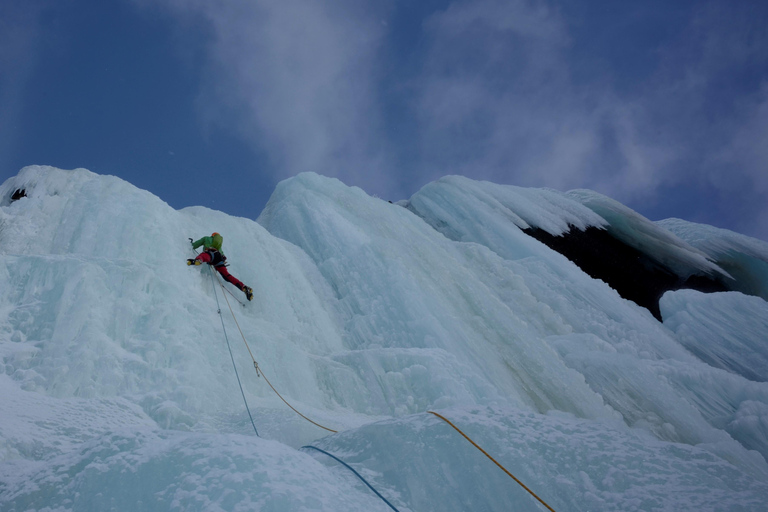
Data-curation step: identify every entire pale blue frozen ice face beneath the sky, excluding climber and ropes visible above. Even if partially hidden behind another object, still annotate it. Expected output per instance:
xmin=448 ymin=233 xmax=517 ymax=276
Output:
xmin=0 ymin=167 xmax=768 ymax=511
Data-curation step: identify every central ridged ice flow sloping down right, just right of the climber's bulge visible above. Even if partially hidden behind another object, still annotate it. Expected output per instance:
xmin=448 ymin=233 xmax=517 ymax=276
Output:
xmin=258 ymin=174 xmax=612 ymax=417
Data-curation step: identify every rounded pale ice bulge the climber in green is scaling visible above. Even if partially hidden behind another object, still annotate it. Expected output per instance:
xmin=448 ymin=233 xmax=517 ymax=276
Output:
xmin=0 ymin=167 xmax=348 ymax=438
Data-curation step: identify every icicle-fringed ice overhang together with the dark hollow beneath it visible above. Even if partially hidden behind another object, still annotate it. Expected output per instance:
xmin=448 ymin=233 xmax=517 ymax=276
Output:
xmin=402 ymin=176 xmax=744 ymax=320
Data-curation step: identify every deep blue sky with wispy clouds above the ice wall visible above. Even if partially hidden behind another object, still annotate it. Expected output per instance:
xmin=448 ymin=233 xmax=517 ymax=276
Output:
xmin=0 ymin=0 xmax=768 ymax=240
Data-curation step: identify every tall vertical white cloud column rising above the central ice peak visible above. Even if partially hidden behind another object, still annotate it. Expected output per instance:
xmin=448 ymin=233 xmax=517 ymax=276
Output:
xmin=132 ymin=0 xmax=386 ymax=192
